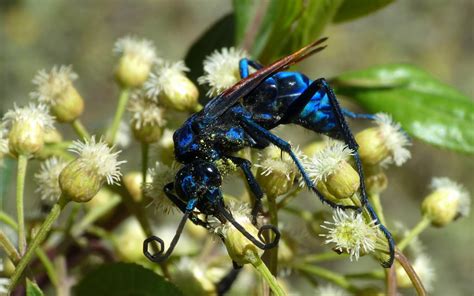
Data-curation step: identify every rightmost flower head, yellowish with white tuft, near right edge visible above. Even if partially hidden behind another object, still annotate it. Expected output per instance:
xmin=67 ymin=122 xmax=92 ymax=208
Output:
xmin=421 ymin=178 xmax=471 ymax=227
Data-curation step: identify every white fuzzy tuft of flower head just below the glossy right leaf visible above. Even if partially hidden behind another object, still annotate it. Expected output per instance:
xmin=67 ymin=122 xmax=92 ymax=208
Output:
xmin=375 ymin=113 xmax=411 ymax=166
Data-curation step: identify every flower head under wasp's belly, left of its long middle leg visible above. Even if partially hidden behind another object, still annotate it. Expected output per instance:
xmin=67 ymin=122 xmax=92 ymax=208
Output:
xmin=256 ymin=145 xmax=303 ymax=198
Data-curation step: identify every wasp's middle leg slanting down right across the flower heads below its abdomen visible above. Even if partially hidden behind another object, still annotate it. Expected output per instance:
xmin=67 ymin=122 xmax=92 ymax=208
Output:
xmin=240 ymin=116 xmax=357 ymax=209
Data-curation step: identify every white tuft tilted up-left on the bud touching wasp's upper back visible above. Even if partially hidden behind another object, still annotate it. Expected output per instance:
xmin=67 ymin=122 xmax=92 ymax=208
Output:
xmin=144 ymin=61 xmax=189 ymax=101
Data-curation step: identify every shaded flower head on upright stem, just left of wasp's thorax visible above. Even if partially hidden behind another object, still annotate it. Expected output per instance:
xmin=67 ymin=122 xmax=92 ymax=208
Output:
xmin=128 ymin=91 xmax=166 ymax=143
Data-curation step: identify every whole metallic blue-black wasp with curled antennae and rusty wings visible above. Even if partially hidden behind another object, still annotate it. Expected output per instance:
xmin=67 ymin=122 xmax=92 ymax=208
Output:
xmin=143 ymin=38 xmax=394 ymax=267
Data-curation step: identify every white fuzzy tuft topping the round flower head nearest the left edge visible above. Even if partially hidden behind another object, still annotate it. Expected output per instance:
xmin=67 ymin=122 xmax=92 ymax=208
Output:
xmin=3 ymin=104 xmax=54 ymax=130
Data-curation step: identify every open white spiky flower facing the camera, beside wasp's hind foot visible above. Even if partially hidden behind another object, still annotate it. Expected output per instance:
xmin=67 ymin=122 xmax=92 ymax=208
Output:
xmin=320 ymin=209 xmax=378 ymax=261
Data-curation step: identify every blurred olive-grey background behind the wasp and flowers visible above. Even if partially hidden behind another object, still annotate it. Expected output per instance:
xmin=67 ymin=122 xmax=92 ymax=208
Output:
xmin=0 ymin=0 xmax=474 ymax=296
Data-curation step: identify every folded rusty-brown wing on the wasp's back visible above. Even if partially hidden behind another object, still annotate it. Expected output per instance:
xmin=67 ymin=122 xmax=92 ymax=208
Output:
xmin=200 ymin=38 xmax=327 ymax=121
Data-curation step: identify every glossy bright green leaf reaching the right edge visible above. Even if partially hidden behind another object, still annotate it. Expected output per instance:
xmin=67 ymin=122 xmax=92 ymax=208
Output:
xmin=334 ymin=64 xmax=474 ymax=153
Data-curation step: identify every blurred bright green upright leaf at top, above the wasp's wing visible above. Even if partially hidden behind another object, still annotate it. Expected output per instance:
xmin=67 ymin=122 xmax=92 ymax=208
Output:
xmin=234 ymin=0 xmax=343 ymax=63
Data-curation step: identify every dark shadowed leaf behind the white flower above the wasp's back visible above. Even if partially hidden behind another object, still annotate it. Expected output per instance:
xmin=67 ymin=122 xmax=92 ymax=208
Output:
xmin=184 ymin=14 xmax=235 ymax=97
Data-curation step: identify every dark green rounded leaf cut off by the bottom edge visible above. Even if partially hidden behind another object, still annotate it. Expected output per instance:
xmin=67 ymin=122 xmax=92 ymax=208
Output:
xmin=74 ymin=263 xmax=183 ymax=296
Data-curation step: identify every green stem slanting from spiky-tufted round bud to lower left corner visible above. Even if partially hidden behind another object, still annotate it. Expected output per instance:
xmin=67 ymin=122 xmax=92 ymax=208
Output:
xmin=8 ymin=196 xmax=69 ymax=293
